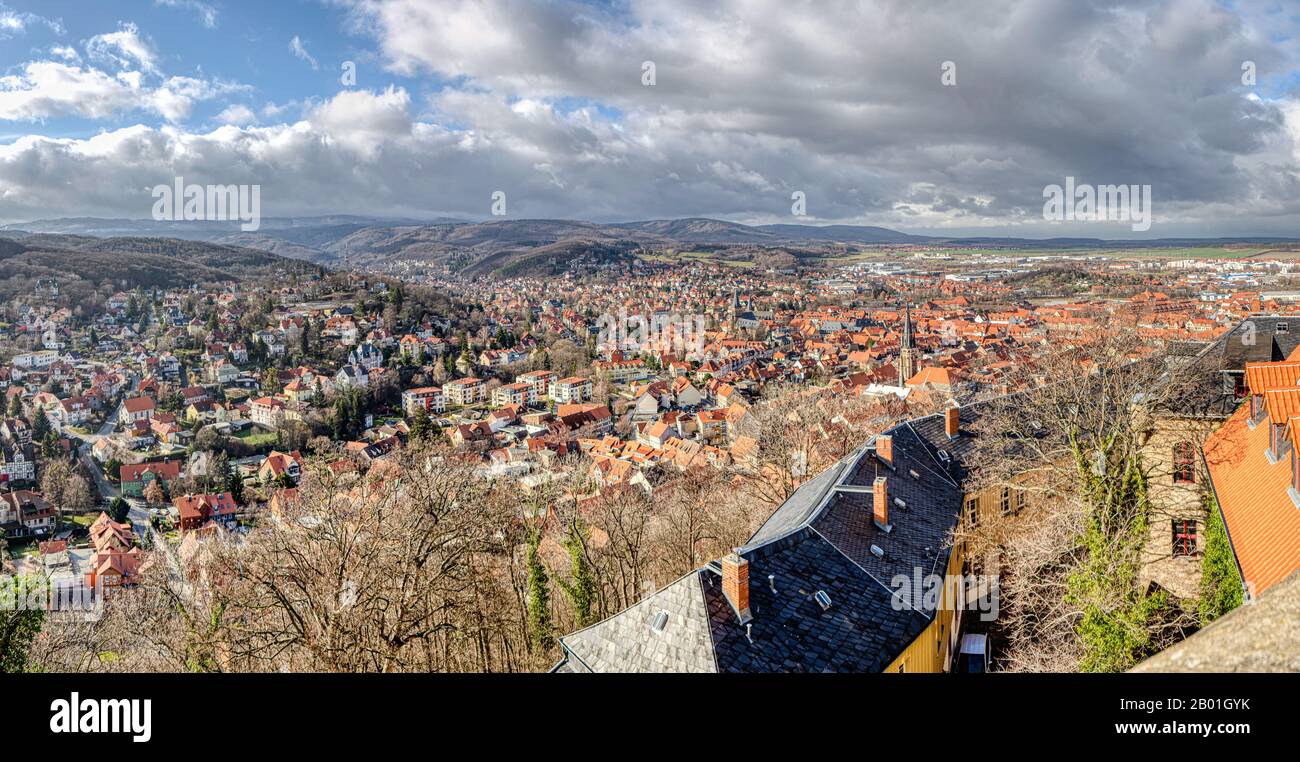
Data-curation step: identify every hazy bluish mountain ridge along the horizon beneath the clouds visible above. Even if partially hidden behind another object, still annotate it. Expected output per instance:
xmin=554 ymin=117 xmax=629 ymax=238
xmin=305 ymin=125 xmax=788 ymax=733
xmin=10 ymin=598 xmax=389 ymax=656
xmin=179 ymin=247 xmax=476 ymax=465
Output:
xmin=10 ymin=215 xmax=1300 ymax=274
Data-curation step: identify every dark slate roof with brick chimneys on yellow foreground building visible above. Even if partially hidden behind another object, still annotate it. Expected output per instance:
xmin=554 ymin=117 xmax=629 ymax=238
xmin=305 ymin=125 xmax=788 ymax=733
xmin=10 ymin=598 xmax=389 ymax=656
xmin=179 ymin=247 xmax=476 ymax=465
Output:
xmin=553 ymin=408 xmax=971 ymax=672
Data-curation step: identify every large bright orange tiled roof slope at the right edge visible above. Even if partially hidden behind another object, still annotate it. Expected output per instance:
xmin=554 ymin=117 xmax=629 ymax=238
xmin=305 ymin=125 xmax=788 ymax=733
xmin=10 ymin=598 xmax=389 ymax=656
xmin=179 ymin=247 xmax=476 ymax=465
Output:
xmin=1205 ymin=403 xmax=1300 ymax=594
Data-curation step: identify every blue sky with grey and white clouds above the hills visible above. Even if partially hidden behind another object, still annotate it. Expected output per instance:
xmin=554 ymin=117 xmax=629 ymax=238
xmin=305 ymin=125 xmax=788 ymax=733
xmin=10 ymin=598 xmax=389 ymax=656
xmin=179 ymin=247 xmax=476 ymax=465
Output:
xmin=0 ymin=0 xmax=1300 ymax=238
